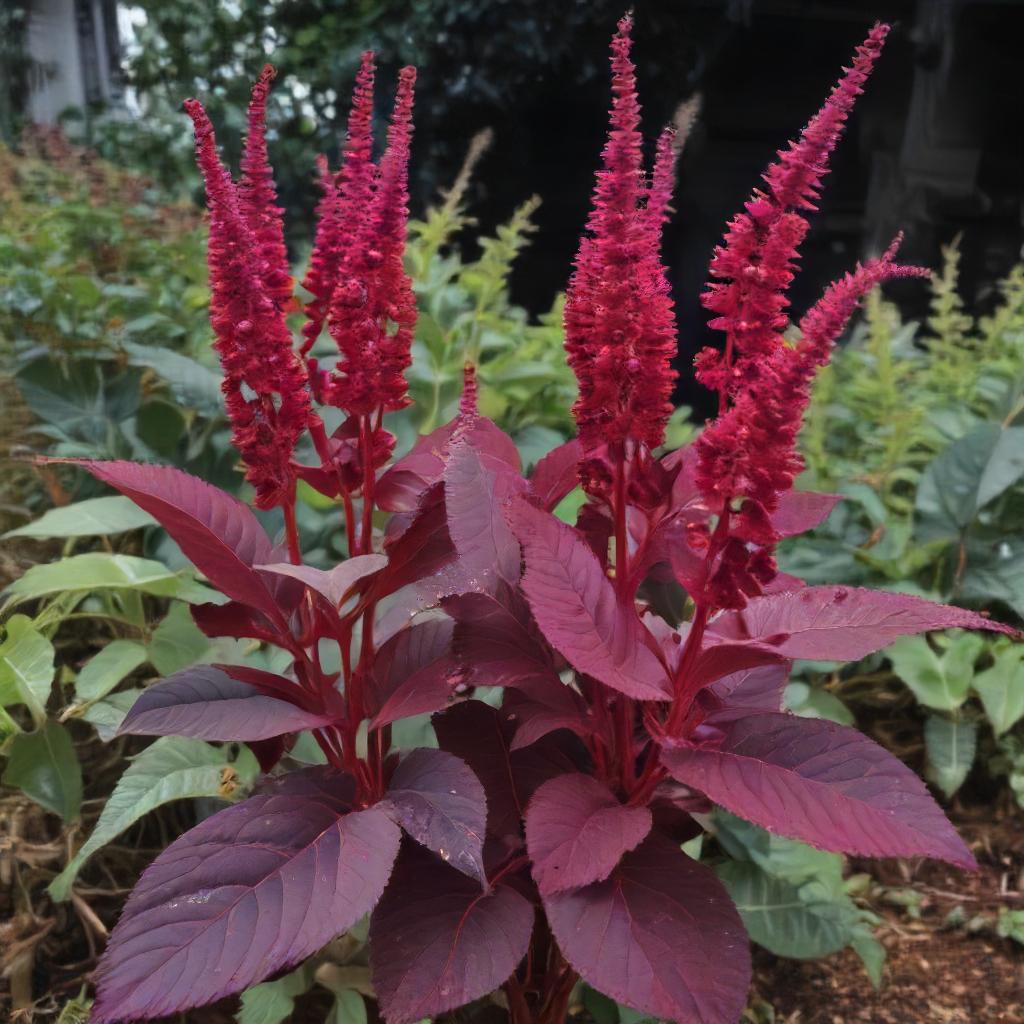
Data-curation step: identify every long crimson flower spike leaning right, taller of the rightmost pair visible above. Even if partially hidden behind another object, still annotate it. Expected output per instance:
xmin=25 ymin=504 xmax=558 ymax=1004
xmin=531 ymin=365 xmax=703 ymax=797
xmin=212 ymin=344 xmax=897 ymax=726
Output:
xmin=697 ymin=23 xmax=889 ymax=399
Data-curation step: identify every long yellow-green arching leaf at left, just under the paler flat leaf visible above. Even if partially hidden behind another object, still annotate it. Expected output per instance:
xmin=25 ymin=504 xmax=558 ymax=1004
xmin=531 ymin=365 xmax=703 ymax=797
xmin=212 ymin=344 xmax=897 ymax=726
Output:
xmin=5 ymin=551 xmax=222 ymax=604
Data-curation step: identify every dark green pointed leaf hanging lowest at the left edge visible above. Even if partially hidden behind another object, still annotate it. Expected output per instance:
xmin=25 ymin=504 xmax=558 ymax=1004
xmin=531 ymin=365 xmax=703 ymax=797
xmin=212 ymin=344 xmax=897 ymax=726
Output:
xmin=3 ymin=722 xmax=82 ymax=821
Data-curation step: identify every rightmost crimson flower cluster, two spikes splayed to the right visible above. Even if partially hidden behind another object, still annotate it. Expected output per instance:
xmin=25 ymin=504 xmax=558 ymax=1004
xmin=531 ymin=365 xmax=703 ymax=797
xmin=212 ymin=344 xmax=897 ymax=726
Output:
xmin=696 ymin=25 xmax=928 ymax=608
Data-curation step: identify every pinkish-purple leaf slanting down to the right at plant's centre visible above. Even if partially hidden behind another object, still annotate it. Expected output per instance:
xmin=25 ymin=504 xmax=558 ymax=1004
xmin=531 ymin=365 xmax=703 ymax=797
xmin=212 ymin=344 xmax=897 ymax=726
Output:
xmin=512 ymin=501 xmax=672 ymax=700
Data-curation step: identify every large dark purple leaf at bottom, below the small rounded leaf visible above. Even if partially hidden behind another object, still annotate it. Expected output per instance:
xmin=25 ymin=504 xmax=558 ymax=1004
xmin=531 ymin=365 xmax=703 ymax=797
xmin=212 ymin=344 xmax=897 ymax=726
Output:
xmin=544 ymin=834 xmax=751 ymax=1024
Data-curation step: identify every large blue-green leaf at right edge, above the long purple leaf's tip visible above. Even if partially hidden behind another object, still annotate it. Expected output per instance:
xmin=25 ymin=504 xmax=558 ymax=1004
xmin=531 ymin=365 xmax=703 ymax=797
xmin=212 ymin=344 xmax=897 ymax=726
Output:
xmin=914 ymin=423 xmax=1024 ymax=541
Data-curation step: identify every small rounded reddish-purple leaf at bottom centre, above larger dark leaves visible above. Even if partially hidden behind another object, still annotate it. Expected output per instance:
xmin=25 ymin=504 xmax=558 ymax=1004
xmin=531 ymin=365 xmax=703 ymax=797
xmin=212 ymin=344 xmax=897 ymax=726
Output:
xmin=526 ymin=772 xmax=651 ymax=894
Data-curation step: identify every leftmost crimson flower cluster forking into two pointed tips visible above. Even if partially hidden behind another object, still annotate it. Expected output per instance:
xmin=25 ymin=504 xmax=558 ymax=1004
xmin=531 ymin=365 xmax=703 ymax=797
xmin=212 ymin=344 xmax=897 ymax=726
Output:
xmin=185 ymin=68 xmax=313 ymax=508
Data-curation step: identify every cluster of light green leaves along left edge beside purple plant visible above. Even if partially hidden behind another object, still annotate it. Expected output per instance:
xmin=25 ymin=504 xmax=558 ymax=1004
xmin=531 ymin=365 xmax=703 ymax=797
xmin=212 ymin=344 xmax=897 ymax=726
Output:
xmin=0 ymin=496 xmax=257 ymax=856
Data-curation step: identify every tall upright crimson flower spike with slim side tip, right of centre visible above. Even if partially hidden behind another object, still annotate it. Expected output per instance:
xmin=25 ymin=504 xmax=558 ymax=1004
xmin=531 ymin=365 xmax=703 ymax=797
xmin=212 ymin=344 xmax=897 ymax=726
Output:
xmin=565 ymin=15 xmax=676 ymax=451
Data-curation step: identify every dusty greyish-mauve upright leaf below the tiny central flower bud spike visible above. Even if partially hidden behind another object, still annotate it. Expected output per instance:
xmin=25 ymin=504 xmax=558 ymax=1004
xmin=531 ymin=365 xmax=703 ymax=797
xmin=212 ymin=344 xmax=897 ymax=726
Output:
xmin=444 ymin=439 xmax=522 ymax=593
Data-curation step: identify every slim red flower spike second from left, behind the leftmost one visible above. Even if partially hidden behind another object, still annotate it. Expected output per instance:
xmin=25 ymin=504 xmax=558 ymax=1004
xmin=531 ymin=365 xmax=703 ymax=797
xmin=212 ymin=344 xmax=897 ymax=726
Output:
xmin=239 ymin=65 xmax=293 ymax=309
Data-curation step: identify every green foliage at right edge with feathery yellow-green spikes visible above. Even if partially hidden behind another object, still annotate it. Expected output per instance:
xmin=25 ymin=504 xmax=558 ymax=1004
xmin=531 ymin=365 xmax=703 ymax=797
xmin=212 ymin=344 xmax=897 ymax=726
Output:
xmin=785 ymin=243 xmax=1024 ymax=797
